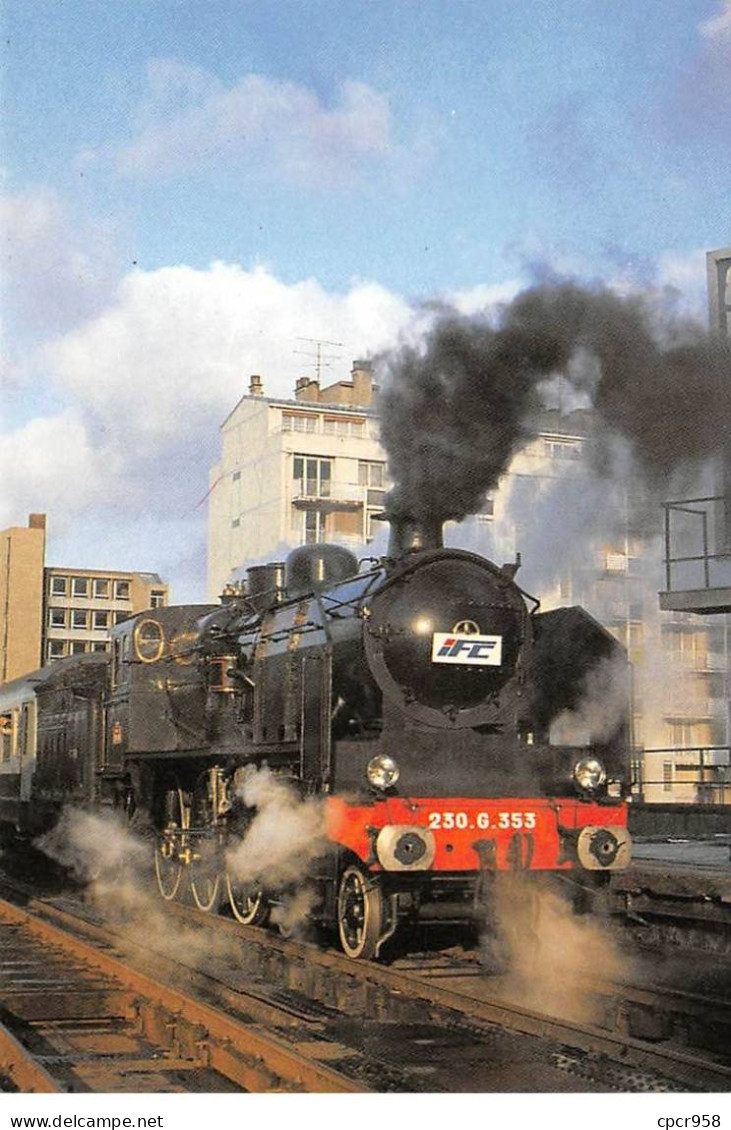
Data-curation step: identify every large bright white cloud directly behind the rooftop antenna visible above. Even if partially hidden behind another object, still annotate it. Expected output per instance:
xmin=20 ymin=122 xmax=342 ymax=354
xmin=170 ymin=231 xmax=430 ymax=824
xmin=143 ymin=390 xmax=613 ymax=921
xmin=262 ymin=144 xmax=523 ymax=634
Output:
xmin=45 ymin=263 xmax=409 ymax=442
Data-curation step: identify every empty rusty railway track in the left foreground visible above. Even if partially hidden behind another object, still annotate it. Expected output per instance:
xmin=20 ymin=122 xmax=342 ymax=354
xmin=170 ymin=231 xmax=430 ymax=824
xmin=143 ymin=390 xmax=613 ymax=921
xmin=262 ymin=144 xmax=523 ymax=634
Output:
xmin=0 ymin=899 xmax=363 ymax=1093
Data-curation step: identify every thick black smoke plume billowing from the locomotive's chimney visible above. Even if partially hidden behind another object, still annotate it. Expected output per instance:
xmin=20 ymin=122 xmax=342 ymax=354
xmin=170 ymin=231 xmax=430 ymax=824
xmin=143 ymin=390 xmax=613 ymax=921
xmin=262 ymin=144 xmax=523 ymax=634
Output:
xmin=380 ymin=284 xmax=731 ymax=521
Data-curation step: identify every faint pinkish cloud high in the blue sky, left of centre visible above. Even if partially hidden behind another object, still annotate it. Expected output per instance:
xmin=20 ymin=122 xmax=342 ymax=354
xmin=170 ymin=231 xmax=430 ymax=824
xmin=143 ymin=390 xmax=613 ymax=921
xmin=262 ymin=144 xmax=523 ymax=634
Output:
xmin=116 ymin=60 xmax=398 ymax=189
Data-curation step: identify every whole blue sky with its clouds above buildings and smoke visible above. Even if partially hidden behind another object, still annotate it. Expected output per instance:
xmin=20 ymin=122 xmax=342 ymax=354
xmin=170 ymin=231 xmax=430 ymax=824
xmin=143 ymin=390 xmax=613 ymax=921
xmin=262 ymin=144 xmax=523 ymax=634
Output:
xmin=0 ymin=0 xmax=731 ymax=599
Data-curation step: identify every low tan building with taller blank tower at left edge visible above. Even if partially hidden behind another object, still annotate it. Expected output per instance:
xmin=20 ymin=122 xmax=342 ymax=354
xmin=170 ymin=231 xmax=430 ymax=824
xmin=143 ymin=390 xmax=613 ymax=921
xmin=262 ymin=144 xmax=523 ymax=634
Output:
xmin=0 ymin=514 xmax=168 ymax=683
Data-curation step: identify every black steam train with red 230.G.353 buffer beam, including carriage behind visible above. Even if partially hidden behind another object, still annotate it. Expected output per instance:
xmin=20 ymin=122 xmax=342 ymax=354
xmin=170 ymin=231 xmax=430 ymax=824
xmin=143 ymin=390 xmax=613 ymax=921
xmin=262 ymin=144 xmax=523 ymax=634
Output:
xmin=0 ymin=515 xmax=630 ymax=958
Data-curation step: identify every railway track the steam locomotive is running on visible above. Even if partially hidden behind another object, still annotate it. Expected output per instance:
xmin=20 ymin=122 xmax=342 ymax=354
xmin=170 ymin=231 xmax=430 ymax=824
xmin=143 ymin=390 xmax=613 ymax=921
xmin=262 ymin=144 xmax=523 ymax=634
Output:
xmin=1 ymin=867 xmax=731 ymax=1092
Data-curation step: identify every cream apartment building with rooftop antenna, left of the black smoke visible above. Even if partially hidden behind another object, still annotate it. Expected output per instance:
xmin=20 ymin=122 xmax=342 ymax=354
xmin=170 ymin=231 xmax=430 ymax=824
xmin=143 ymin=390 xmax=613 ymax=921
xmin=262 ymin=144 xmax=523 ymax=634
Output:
xmin=208 ymin=360 xmax=388 ymax=600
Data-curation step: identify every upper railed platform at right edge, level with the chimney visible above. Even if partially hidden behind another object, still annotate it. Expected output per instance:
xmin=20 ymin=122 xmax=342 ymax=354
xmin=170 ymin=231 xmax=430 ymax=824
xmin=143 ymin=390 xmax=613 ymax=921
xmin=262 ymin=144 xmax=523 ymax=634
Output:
xmin=660 ymin=495 xmax=731 ymax=615
